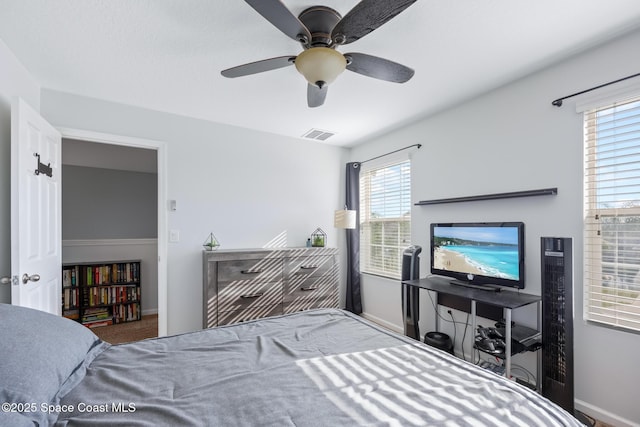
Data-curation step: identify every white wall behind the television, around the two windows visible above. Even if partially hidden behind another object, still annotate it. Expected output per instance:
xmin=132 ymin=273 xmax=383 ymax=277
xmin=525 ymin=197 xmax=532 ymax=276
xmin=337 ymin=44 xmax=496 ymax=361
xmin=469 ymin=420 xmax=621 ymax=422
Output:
xmin=351 ymin=28 xmax=640 ymax=425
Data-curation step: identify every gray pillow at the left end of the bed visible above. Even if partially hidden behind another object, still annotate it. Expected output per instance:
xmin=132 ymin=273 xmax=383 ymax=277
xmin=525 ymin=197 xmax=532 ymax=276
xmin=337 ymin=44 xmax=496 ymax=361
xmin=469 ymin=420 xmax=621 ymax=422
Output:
xmin=0 ymin=304 xmax=109 ymax=425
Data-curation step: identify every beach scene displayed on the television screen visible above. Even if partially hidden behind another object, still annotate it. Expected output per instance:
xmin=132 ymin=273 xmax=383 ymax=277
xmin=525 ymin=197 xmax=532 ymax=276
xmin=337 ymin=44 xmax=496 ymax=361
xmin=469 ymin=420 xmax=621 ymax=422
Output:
xmin=433 ymin=227 xmax=520 ymax=280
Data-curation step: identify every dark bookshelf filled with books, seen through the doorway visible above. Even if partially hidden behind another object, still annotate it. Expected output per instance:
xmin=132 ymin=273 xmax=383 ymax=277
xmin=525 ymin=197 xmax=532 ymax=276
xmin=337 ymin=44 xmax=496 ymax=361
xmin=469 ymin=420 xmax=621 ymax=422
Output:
xmin=62 ymin=261 xmax=142 ymax=328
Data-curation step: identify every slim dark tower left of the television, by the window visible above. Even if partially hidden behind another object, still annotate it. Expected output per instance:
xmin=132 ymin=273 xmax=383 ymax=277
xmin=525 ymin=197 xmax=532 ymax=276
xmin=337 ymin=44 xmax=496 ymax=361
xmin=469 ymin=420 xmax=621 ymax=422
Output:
xmin=401 ymin=246 xmax=422 ymax=340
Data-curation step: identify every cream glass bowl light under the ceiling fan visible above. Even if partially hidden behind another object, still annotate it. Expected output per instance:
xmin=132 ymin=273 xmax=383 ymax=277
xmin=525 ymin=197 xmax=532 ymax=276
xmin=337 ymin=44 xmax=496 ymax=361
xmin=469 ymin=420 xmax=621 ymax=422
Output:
xmin=295 ymin=47 xmax=347 ymax=88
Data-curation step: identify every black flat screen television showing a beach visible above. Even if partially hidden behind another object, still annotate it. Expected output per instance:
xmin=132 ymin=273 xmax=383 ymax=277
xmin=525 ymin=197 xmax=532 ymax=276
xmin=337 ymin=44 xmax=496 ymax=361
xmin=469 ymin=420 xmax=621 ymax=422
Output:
xmin=431 ymin=222 xmax=524 ymax=290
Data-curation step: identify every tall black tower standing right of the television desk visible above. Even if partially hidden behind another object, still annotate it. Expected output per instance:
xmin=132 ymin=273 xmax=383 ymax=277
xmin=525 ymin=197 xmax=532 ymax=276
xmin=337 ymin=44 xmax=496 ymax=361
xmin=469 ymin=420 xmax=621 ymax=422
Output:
xmin=540 ymin=237 xmax=575 ymax=414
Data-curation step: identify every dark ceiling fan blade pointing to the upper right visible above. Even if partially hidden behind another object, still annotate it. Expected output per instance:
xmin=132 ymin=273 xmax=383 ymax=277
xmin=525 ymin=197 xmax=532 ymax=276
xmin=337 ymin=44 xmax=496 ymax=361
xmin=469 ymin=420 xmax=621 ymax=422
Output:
xmin=331 ymin=0 xmax=416 ymax=44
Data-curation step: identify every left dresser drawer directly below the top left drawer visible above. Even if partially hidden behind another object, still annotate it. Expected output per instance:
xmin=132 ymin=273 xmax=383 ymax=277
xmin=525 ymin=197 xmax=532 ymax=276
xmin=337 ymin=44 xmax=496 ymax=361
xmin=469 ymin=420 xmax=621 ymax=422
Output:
xmin=218 ymin=281 xmax=282 ymax=314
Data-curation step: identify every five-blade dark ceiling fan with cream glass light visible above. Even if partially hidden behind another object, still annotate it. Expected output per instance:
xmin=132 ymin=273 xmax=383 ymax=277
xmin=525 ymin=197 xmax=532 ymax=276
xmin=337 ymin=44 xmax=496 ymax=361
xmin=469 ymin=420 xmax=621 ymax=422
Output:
xmin=221 ymin=0 xmax=416 ymax=107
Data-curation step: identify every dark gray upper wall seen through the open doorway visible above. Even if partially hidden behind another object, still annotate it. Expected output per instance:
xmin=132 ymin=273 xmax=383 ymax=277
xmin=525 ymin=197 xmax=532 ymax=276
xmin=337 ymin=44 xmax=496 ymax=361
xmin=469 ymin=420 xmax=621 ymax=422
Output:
xmin=62 ymin=166 xmax=158 ymax=240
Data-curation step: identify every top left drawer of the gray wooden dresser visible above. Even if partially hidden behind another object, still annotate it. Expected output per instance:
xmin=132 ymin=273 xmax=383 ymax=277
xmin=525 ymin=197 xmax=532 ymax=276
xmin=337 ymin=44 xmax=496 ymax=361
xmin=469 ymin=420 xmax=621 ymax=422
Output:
xmin=217 ymin=257 xmax=282 ymax=286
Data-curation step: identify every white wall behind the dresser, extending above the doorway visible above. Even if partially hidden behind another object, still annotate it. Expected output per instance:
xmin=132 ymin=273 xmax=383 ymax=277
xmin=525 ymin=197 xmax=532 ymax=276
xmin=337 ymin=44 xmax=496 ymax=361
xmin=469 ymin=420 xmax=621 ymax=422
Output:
xmin=42 ymin=90 xmax=346 ymax=333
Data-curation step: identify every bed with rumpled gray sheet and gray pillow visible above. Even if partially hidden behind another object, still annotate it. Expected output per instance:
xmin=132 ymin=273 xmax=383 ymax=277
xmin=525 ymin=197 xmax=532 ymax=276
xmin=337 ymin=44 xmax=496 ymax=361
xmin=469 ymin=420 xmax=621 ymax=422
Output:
xmin=0 ymin=304 xmax=582 ymax=427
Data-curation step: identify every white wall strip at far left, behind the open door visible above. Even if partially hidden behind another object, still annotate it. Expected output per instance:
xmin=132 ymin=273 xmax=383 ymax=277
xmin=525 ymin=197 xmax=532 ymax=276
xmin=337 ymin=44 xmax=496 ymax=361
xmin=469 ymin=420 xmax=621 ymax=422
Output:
xmin=0 ymin=40 xmax=40 ymax=303
